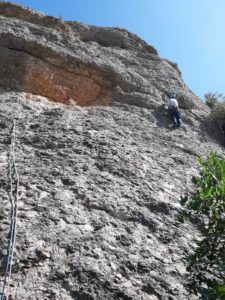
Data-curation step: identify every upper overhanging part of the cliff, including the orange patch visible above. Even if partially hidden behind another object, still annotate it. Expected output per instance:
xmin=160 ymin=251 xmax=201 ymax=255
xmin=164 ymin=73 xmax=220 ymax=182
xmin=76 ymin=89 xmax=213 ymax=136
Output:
xmin=0 ymin=3 xmax=204 ymax=107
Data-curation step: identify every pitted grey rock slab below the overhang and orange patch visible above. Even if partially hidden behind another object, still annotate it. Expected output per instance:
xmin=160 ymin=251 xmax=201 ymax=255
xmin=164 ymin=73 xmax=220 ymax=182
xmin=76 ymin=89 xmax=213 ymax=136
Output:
xmin=0 ymin=90 xmax=222 ymax=300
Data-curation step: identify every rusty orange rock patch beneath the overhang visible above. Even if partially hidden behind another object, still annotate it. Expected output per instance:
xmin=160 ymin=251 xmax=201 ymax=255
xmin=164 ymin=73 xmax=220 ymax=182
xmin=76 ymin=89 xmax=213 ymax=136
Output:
xmin=23 ymin=58 xmax=112 ymax=106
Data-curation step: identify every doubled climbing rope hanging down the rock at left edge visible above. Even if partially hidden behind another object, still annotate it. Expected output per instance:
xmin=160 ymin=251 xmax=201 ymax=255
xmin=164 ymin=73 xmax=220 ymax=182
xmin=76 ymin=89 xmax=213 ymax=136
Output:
xmin=0 ymin=120 xmax=19 ymax=300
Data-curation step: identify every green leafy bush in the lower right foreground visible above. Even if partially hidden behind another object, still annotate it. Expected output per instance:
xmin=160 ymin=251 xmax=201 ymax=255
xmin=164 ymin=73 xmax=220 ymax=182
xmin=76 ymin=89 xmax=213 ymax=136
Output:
xmin=181 ymin=152 xmax=225 ymax=300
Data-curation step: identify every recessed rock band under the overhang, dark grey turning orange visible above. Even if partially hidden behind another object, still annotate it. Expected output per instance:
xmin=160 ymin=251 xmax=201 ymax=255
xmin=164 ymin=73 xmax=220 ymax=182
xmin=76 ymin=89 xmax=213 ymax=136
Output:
xmin=0 ymin=47 xmax=111 ymax=106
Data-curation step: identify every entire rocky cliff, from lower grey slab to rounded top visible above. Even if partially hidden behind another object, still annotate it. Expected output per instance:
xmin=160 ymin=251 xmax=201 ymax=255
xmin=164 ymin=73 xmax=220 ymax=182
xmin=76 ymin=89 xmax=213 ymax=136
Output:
xmin=0 ymin=3 xmax=222 ymax=300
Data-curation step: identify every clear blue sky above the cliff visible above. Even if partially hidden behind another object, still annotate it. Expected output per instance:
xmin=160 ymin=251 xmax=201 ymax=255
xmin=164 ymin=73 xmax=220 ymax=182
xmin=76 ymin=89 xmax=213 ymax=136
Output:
xmin=4 ymin=0 xmax=225 ymax=98
